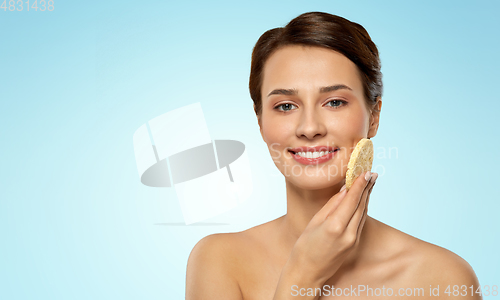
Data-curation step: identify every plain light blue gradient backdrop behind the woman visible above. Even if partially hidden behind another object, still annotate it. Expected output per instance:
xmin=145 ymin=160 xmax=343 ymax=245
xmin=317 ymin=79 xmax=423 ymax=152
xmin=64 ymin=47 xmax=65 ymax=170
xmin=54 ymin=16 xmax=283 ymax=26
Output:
xmin=0 ymin=0 xmax=500 ymax=299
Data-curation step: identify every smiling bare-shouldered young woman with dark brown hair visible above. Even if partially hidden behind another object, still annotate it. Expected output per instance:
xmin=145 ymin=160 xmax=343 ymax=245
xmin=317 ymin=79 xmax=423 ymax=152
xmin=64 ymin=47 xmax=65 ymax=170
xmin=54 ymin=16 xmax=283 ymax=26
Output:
xmin=186 ymin=12 xmax=481 ymax=300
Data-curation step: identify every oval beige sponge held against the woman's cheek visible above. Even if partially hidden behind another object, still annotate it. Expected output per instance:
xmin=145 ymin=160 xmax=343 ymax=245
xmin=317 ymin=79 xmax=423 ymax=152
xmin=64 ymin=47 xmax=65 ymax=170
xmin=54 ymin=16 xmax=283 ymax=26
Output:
xmin=345 ymin=138 xmax=373 ymax=190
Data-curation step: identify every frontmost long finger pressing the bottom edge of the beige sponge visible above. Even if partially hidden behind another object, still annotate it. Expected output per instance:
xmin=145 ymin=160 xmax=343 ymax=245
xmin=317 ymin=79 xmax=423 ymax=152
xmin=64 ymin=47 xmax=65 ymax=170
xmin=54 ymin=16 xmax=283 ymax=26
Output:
xmin=328 ymin=172 xmax=370 ymax=229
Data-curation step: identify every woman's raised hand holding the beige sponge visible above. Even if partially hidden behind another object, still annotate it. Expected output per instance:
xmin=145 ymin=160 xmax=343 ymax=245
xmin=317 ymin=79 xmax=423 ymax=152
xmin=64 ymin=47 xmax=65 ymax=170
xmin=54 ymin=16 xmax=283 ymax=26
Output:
xmin=287 ymin=172 xmax=378 ymax=285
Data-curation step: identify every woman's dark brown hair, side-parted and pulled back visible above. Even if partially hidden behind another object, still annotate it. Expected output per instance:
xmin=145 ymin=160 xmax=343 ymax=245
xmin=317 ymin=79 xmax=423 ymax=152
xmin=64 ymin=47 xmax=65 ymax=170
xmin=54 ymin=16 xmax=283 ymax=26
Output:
xmin=249 ymin=12 xmax=382 ymax=116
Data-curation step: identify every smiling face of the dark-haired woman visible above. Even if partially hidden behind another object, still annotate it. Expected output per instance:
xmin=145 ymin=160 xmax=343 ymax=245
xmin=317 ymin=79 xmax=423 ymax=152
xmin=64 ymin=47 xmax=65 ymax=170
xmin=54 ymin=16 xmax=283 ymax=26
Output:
xmin=259 ymin=45 xmax=381 ymax=189
